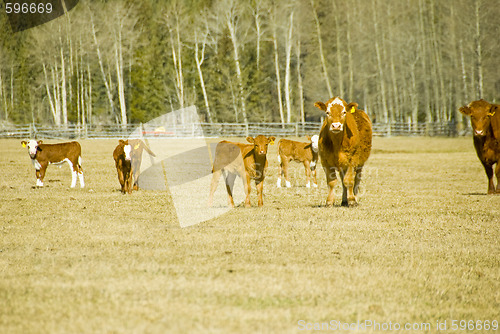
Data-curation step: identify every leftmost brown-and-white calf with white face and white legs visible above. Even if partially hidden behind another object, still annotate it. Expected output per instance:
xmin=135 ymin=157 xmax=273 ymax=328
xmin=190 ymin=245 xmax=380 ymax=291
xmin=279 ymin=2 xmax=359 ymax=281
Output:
xmin=21 ymin=140 xmax=85 ymax=188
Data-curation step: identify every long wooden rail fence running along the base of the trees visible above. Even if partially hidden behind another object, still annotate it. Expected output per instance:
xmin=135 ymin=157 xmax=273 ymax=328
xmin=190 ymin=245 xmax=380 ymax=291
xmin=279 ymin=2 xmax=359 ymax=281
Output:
xmin=0 ymin=122 xmax=472 ymax=139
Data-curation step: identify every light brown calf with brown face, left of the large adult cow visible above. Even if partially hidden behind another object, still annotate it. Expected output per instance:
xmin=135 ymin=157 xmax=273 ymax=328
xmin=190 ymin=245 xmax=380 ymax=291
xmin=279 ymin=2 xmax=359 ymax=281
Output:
xmin=208 ymin=135 xmax=276 ymax=207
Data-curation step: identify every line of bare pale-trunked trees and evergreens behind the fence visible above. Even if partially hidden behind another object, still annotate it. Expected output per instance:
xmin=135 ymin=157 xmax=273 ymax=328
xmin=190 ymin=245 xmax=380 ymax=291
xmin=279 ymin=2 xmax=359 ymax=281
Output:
xmin=0 ymin=0 xmax=500 ymax=127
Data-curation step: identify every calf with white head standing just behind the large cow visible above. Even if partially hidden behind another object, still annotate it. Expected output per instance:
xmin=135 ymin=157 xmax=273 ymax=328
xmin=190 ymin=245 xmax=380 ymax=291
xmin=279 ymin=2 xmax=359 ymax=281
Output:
xmin=276 ymin=135 xmax=319 ymax=188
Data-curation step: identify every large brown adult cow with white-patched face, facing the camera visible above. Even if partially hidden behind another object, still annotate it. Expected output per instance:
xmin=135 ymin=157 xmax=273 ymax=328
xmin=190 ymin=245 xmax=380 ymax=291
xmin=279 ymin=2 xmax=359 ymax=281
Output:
xmin=314 ymin=97 xmax=372 ymax=206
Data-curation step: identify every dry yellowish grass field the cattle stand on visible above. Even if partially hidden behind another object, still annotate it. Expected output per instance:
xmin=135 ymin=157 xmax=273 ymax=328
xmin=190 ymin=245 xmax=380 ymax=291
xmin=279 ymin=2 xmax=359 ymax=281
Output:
xmin=0 ymin=138 xmax=500 ymax=333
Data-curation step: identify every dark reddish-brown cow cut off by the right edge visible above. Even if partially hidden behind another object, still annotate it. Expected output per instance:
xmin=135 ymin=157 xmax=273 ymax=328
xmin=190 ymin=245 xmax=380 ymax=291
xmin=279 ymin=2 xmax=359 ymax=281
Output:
xmin=459 ymin=100 xmax=500 ymax=194
